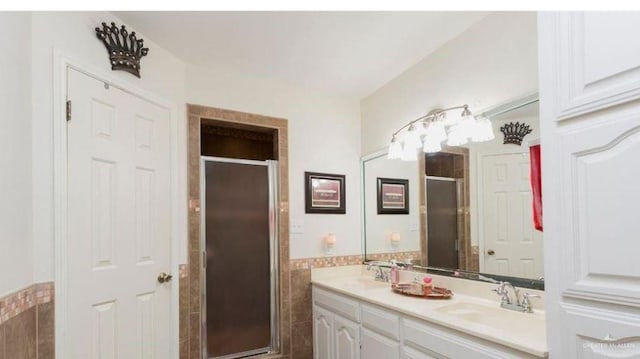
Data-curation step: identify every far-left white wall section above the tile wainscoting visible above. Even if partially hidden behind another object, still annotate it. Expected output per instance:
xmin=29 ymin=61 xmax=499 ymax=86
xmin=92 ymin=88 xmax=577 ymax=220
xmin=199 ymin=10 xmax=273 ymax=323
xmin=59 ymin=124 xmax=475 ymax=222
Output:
xmin=0 ymin=12 xmax=33 ymax=297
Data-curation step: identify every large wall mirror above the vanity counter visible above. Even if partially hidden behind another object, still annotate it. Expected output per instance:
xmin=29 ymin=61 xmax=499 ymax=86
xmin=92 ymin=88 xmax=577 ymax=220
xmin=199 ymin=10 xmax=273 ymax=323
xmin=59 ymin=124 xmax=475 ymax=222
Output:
xmin=362 ymin=95 xmax=544 ymax=288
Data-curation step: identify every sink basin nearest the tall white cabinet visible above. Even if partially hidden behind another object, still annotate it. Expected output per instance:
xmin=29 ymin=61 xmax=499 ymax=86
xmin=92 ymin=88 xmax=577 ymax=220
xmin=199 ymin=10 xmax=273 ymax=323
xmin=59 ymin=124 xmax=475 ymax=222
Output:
xmin=436 ymin=302 xmax=544 ymax=331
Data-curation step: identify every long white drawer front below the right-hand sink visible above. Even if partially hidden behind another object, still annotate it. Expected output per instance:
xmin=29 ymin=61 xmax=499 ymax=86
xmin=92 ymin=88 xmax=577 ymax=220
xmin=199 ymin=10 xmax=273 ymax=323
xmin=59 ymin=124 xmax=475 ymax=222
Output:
xmin=402 ymin=318 xmax=534 ymax=359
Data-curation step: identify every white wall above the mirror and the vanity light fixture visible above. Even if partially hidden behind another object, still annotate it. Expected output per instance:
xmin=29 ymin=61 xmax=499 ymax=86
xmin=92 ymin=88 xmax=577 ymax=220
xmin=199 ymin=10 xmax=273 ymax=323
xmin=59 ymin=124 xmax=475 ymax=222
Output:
xmin=361 ymin=12 xmax=538 ymax=154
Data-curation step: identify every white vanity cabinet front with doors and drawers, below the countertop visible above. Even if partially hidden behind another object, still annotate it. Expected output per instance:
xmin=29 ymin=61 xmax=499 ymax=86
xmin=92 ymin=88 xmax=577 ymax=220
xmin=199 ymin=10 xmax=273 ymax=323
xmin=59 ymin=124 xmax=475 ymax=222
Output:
xmin=313 ymin=285 xmax=535 ymax=359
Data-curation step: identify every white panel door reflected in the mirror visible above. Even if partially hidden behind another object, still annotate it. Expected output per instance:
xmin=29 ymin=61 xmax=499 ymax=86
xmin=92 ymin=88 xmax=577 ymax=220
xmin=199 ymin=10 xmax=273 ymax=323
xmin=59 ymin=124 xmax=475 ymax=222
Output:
xmin=480 ymin=152 xmax=544 ymax=278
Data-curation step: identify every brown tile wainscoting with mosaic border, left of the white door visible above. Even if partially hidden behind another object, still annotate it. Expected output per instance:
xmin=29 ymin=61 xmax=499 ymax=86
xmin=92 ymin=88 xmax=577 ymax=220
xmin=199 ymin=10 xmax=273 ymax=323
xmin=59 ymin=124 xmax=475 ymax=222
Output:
xmin=0 ymin=282 xmax=55 ymax=359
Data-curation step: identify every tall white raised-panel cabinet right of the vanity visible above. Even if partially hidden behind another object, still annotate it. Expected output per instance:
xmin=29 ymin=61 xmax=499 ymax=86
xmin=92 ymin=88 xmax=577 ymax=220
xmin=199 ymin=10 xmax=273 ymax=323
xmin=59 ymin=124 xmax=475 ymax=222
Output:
xmin=538 ymin=12 xmax=640 ymax=359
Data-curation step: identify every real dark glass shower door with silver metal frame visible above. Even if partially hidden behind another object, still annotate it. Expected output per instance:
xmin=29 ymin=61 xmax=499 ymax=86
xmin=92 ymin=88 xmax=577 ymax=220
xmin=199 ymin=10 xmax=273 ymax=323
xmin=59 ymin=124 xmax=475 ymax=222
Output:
xmin=201 ymin=157 xmax=278 ymax=358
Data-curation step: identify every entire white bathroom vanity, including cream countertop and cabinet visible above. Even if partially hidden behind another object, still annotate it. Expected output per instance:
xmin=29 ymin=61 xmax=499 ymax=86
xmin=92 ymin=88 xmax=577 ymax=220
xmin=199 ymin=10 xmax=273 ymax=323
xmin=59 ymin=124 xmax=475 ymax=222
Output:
xmin=311 ymin=266 xmax=548 ymax=359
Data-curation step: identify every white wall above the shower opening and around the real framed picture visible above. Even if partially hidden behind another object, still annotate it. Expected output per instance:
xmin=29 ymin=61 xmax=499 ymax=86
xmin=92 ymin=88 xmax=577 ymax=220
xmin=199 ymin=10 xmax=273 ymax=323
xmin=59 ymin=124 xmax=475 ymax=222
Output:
xmin=187 ymin=66 xmax=361 ymax=258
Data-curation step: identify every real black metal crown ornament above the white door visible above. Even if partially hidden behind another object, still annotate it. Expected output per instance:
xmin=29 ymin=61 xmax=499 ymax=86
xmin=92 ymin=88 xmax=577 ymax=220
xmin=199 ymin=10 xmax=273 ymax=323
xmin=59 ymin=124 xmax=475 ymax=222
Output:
xmin=96 ymin=22 xmax=149 ymax=78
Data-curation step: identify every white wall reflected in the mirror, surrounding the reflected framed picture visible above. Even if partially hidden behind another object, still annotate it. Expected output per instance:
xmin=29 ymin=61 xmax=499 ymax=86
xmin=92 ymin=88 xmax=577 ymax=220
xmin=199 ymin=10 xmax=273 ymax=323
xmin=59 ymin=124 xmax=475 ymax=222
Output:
xmin=364 ymin=155 xmax=420 ymax=259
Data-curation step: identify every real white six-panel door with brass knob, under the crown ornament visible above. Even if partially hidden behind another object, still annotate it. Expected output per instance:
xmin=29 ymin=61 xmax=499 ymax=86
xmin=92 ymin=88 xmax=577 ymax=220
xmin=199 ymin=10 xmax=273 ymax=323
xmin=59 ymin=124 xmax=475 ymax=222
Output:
xmin=66 ymin=69 xmax=172 ymax=359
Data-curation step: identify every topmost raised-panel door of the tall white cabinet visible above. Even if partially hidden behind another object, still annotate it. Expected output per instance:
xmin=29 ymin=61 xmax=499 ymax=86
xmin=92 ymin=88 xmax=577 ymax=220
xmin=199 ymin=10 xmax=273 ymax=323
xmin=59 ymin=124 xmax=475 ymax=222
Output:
xmin=550 ymin=11 xmax=640 ymax=121
